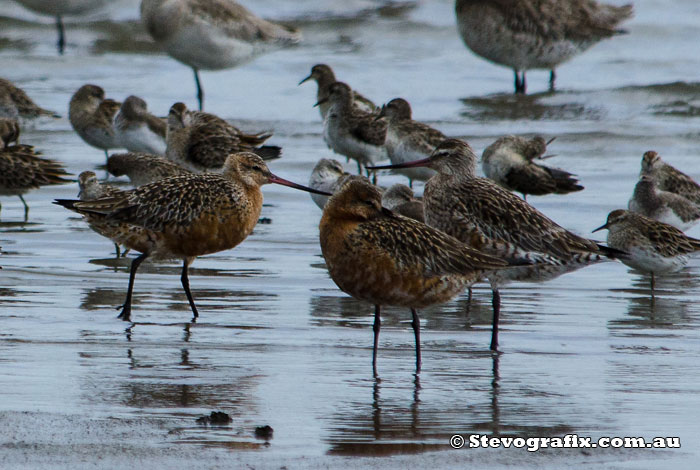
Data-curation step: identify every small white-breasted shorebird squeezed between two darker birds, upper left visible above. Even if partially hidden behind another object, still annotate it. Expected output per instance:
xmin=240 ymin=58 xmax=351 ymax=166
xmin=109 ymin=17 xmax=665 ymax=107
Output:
xmin=113 ymin=95 xmax=168 ymax=155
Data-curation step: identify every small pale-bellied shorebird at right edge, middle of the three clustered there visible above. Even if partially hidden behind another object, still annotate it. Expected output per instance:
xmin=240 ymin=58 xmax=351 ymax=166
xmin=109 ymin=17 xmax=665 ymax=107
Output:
xmin=628 ymin=174 xmax=700 ymax=230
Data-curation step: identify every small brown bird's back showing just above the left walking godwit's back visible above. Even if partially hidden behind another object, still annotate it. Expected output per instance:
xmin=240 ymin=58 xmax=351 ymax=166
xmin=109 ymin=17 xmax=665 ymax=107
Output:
xmin=107 ymin=152 xmax=191 ymax=187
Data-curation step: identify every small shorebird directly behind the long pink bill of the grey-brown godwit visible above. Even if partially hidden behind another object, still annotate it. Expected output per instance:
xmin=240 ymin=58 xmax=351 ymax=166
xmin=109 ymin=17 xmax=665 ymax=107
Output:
xmin=379 ymin=98 xmax=440 ymax=187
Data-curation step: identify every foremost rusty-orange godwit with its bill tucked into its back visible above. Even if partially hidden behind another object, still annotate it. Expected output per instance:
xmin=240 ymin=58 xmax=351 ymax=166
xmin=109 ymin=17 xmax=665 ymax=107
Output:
xmin=319 ymin=181 xmax=507 ymax=374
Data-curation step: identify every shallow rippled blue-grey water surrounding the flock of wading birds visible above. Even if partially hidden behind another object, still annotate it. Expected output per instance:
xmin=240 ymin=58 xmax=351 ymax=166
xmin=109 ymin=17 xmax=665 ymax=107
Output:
xmin=0 ymin=0 xmax=700 ymax=468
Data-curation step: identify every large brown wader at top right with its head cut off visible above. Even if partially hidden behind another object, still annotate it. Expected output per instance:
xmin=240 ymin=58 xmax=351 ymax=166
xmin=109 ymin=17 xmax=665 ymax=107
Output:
xmin=455 ymin=0 xmax=633 ymax=93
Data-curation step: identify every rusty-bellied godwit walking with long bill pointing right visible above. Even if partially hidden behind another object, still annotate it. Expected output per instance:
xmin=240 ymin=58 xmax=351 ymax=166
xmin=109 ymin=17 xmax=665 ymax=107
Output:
xmin=54 ymin=152 xmax=328 ymax=321
